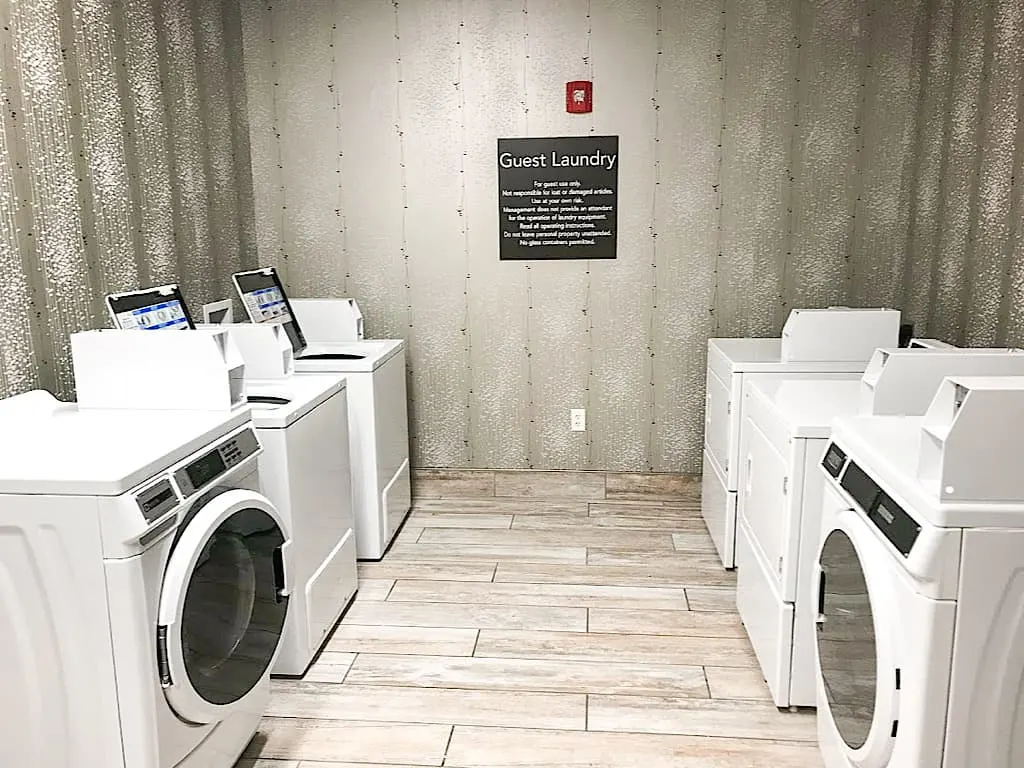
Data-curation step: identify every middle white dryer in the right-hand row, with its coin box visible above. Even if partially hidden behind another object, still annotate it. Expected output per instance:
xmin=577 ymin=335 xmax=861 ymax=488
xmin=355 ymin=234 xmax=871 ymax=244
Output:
xmin=736 ymin=348 xmax=1024 ymax=707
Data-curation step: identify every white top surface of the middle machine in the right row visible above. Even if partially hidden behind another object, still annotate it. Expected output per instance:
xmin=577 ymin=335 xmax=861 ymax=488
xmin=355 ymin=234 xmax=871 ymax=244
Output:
xmin=750 ymin=378 xmax=860 ymax=438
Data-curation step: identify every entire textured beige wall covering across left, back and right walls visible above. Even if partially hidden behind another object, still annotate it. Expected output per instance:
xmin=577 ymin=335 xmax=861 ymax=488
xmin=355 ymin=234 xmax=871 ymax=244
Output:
xmin=0 ymin=0 xmax=1024 ymax=471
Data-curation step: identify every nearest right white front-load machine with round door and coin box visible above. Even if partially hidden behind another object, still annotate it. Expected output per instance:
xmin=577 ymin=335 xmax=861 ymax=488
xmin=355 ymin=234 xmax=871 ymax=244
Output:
xmin=811 ymin=377 xmax=1024 ymax=768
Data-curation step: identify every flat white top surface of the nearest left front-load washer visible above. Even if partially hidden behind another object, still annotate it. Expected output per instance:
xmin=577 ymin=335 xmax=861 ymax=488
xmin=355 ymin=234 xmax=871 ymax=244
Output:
xmin=0 ymin=391 xmax=249 ymax=496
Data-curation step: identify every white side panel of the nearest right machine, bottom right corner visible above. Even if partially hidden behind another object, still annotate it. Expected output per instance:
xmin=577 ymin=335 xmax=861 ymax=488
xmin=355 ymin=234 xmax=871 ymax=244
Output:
xmin=945 ymin=529 xmax=1024 ymax=768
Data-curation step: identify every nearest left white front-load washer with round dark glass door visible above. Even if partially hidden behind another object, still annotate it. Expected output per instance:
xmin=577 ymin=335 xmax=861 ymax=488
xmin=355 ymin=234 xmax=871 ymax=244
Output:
xmin=0 ymin=391 xmax=291 ymax=768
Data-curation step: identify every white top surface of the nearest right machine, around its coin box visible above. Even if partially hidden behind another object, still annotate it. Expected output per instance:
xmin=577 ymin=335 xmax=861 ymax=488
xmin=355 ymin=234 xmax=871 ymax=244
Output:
xmin=833 ymin=416 xmax=1024 ymax=528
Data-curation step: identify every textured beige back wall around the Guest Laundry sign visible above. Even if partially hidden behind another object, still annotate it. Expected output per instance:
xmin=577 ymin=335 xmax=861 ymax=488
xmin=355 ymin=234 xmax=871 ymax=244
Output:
xmin=237 ymin=0 xmax=950 ymax=471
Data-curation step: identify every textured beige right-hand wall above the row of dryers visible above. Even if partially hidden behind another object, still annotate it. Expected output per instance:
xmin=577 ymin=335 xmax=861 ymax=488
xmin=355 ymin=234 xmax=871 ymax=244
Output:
xmin=905 ymin=0 xmax=1024 ymax=345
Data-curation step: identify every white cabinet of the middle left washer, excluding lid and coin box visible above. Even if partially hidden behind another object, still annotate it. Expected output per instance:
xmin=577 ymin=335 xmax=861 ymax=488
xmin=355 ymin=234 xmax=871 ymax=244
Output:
xmin=246 ymin=374 xmax=356 ymax=675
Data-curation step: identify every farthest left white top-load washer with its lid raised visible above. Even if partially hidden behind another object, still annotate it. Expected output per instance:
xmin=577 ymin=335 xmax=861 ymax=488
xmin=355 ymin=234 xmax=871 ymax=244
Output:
xmin=233 ymin=267 xmax=412 ymax=560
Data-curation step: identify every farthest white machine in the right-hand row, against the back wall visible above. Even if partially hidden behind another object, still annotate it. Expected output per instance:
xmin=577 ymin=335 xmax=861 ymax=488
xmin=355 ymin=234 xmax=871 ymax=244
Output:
xmin=700 ymin=308 xmax=900 ymax=568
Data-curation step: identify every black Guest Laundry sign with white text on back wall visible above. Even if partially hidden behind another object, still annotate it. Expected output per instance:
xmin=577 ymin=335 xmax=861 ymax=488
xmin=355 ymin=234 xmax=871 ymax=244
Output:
xmin=498 ymin=136 xmax=618 ymax=260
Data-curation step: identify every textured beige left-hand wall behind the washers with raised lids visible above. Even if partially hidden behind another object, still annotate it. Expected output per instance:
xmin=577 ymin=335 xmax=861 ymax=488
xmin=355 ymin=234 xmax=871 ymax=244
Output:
xmin=0 ymin=0 xmax=255 ymax=396
